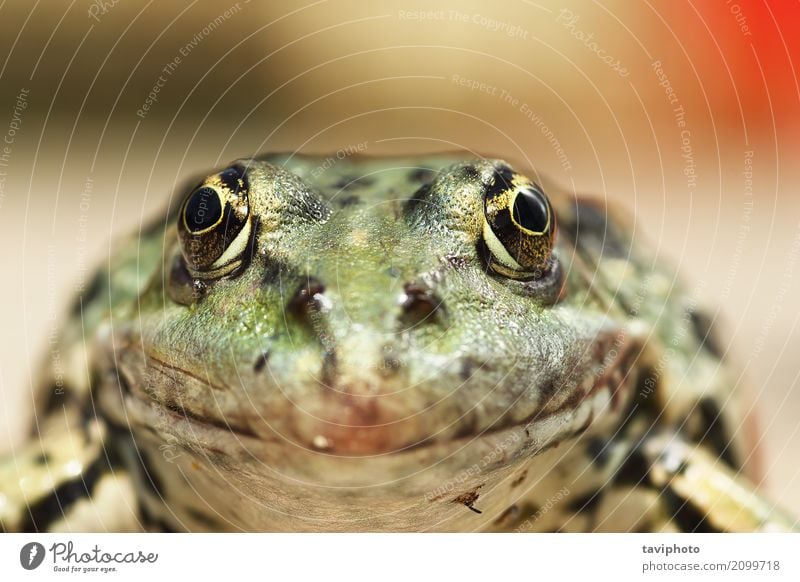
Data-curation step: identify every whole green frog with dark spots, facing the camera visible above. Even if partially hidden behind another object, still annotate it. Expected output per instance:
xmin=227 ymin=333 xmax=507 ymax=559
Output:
xmin=0 ymin=152 xmax=797 ymax=533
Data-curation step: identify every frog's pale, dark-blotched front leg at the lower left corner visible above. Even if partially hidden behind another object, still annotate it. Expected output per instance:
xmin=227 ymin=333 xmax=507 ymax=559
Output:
xmin=0 ymin=408 xmax=142 ymax=532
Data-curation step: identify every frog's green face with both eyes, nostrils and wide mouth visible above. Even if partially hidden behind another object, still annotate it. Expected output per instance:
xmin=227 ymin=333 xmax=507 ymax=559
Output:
xmin=111 ymin=158 xmax=628 ymax=474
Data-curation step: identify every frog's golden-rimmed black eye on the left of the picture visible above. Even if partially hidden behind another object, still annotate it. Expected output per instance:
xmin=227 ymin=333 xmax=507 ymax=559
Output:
xmin=178 ymin=167 xmax=252 ymax=278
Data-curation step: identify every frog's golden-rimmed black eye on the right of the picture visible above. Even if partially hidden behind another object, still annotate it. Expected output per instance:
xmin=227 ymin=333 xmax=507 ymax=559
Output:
xmin=483 ymin=169 xmax=556 ymax=279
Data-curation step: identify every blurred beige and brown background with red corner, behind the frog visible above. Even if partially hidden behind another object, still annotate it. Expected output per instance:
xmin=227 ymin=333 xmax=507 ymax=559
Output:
xmin=0 ymin=0 xmax=800 ymax=512
